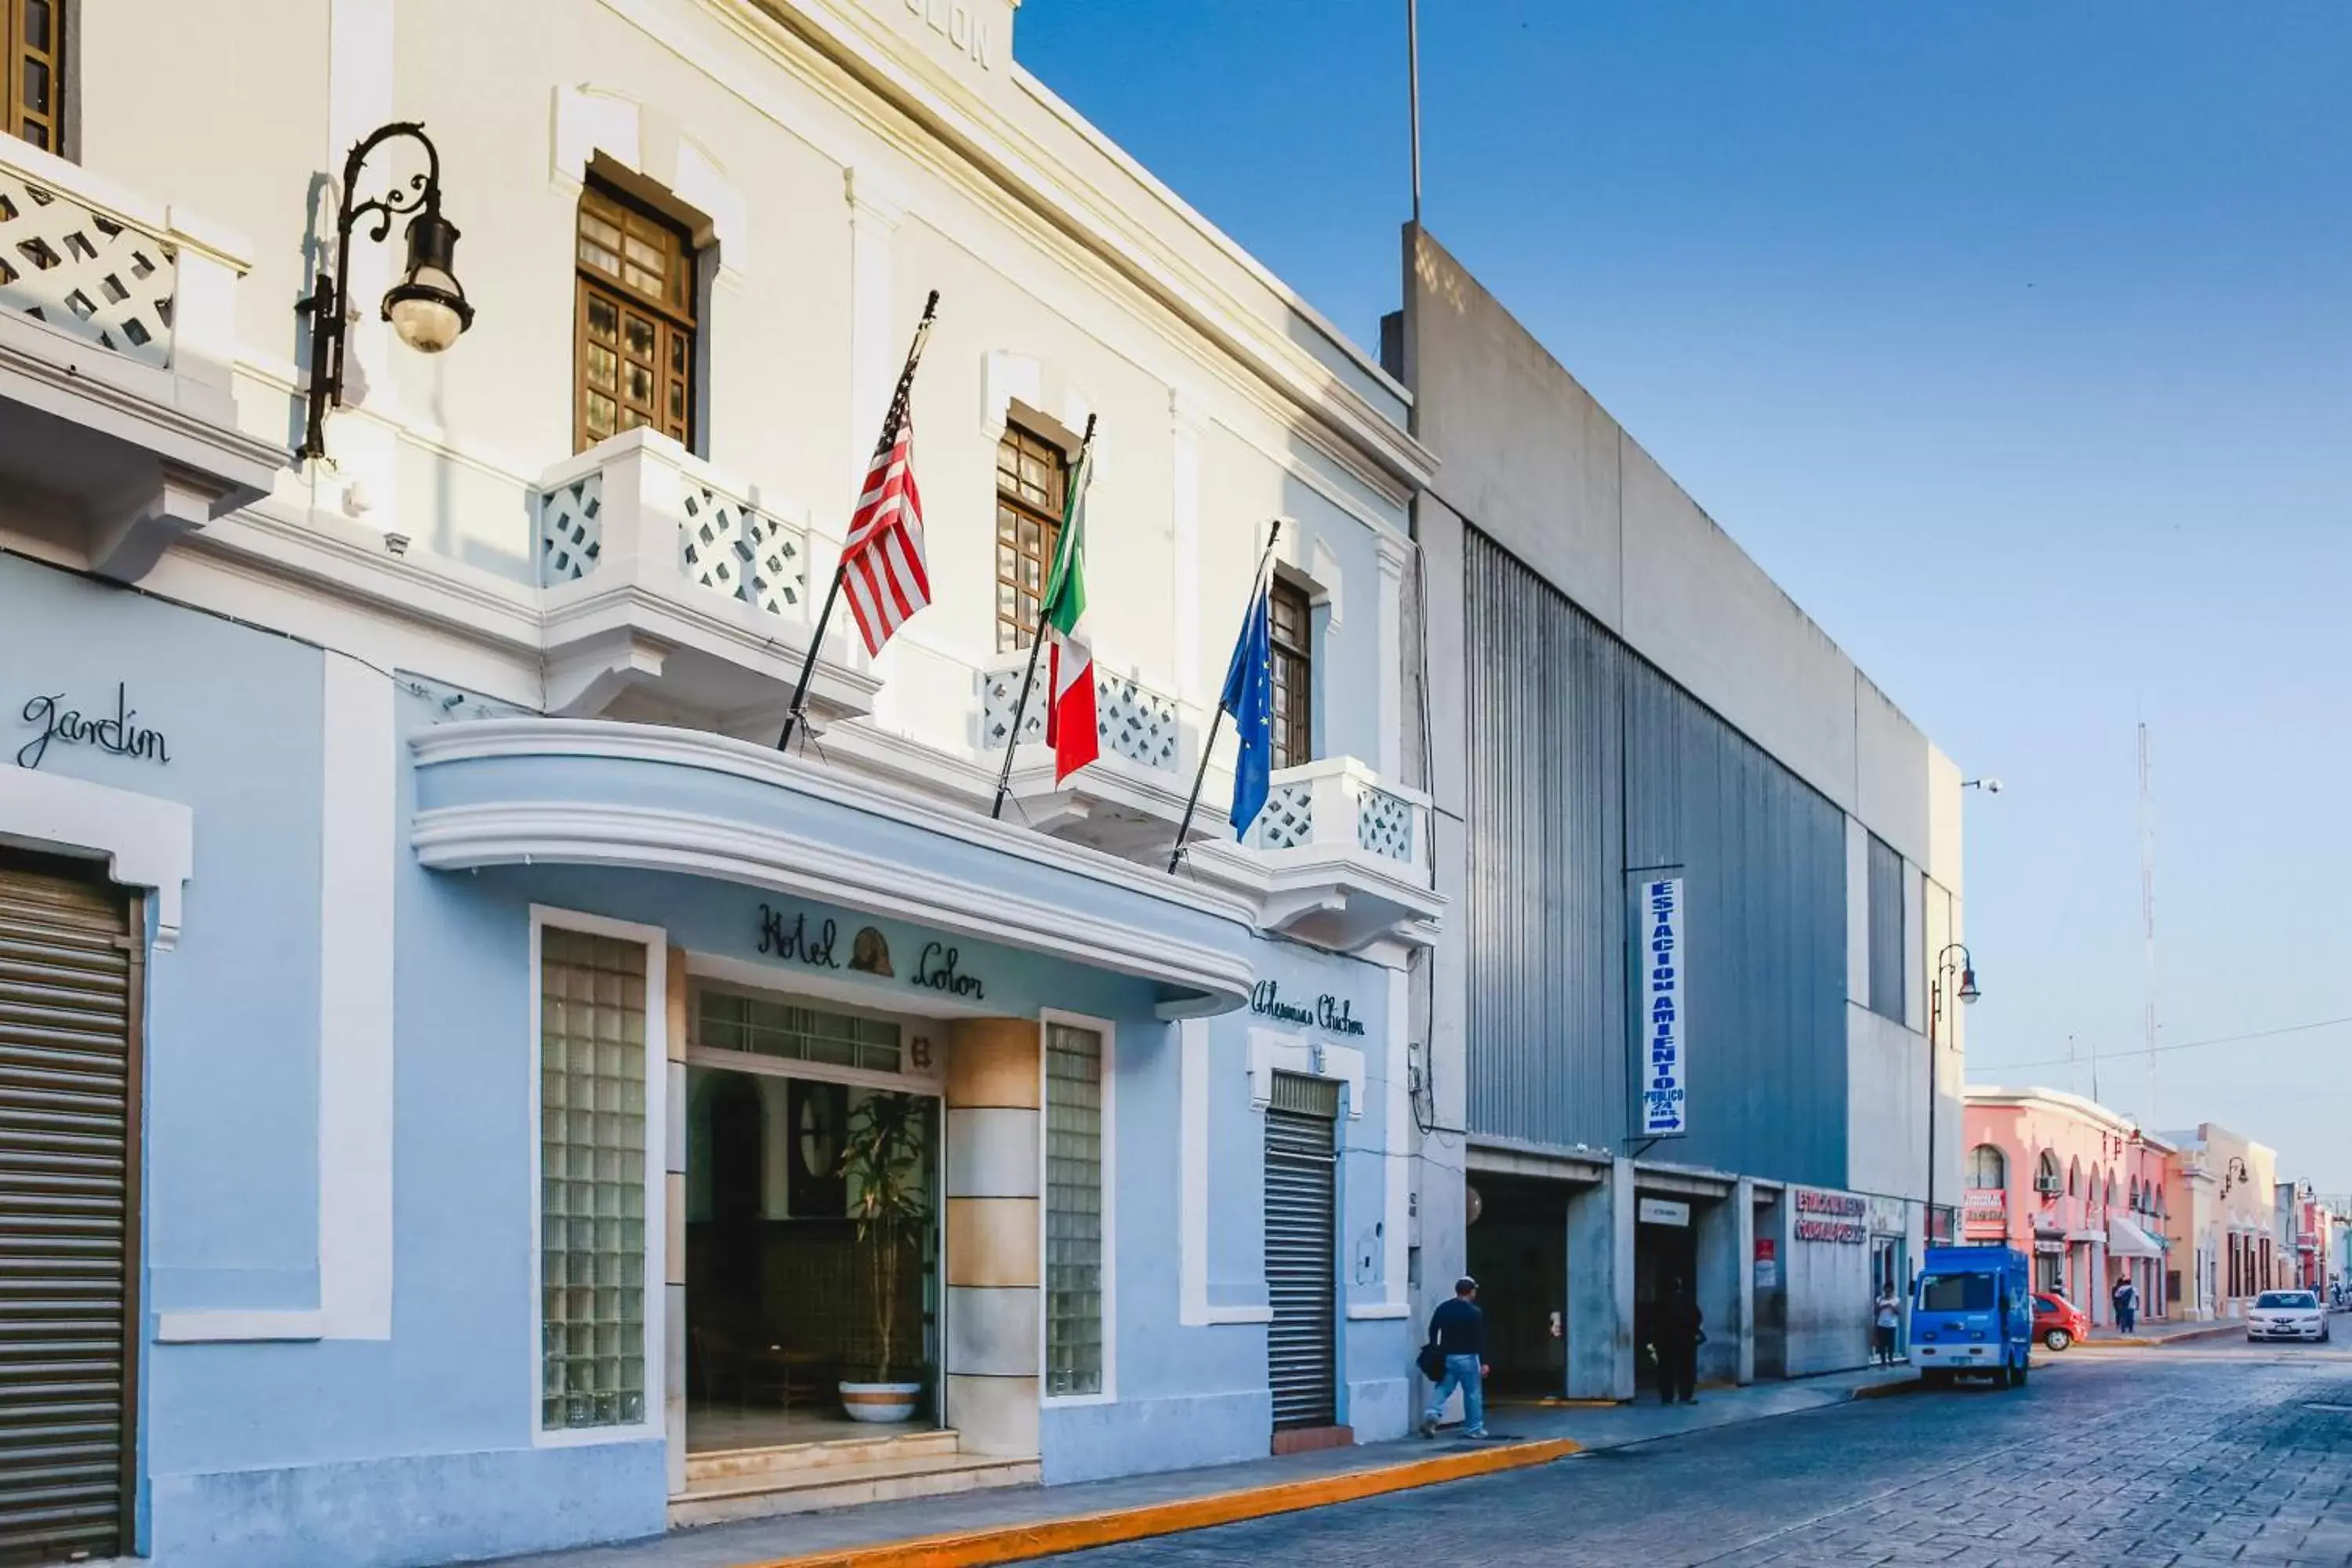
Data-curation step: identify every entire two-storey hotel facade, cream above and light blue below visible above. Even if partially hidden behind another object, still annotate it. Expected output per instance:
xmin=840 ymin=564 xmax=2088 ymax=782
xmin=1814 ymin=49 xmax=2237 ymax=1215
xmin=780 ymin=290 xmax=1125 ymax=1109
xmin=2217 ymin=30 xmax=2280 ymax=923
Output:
xmin=0 ymin=0 xmax=1444 ymax=1568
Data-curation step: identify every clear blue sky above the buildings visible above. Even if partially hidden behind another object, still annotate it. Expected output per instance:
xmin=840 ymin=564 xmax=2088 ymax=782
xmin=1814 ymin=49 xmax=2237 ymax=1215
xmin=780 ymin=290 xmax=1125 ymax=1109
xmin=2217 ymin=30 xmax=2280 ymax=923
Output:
xmin=1016 ymin=0 xmax=2352 ymax=1189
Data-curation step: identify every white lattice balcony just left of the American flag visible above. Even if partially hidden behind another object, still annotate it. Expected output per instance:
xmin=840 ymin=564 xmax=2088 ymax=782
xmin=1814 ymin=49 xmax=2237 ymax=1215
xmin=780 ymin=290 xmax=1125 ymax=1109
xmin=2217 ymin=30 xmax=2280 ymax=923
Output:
xmin=532 ymin=430 xmax=875 ymax=739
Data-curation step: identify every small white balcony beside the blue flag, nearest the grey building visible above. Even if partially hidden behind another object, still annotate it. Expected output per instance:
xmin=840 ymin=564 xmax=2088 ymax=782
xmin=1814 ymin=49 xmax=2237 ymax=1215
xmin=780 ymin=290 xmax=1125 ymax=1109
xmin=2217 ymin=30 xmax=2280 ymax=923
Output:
xmin=1247 ymin=757 xmax=1444 ymax=952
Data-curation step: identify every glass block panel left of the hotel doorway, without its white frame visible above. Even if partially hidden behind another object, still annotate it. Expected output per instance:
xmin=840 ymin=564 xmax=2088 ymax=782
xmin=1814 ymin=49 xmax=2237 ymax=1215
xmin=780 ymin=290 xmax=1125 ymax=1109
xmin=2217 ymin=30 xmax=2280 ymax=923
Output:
xmin=539 ymin=926 xmax=647 ymax=1432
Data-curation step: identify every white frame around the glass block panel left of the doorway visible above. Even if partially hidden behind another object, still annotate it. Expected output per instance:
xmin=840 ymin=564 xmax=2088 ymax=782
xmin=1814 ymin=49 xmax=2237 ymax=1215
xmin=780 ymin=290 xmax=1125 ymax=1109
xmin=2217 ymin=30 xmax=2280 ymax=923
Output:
xmin=524 ymin=902 xmax=670 ymax=1448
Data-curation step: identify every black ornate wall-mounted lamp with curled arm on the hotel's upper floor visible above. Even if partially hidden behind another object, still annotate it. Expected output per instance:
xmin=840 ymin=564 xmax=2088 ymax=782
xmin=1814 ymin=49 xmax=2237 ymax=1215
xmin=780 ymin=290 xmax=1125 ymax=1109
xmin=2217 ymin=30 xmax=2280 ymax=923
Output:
xmin=296 ymin=120 xmax=473 ymax=459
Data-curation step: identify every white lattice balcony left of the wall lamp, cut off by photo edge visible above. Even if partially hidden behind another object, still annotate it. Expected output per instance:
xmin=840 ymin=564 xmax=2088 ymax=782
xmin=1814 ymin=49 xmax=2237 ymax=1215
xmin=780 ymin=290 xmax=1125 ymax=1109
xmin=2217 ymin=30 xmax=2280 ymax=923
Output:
xmin=0 ymin=136 xmax=287 ymax=581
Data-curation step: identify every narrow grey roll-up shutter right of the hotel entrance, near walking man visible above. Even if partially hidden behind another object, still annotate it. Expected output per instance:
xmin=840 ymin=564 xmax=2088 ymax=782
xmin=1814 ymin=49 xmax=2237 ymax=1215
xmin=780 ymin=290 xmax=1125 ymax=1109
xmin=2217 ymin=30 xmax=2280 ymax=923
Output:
xmin=1265 ymin=1074 xmax=1338 ymax=1432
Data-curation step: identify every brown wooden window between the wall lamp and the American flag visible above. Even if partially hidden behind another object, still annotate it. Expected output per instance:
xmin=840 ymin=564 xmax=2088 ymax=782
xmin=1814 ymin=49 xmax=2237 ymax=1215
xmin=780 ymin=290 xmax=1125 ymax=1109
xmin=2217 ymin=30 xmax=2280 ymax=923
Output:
xmin=572 ymin=179 xmax=703 ymax=454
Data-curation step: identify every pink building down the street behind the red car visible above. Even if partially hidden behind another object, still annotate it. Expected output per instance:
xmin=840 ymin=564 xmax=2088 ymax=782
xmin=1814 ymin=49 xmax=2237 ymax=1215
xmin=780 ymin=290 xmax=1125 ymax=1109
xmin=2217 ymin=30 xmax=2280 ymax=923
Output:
xmin=1962 ymin=1088 xmax=2180 ymax=1326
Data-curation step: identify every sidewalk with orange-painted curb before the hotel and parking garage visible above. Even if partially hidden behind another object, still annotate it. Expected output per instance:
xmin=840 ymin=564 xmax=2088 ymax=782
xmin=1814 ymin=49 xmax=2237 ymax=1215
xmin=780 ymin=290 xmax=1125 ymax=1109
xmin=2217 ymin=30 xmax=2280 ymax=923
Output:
xmin=487 ymin=1366 xmax=1919 ymax=1568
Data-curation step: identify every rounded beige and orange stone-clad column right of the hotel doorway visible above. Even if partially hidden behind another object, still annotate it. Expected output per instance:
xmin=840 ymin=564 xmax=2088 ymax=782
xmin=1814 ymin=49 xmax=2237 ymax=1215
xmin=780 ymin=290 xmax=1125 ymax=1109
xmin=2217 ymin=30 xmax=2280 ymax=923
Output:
xmin=943 ymin=1018 xmax=1044 ymax=1457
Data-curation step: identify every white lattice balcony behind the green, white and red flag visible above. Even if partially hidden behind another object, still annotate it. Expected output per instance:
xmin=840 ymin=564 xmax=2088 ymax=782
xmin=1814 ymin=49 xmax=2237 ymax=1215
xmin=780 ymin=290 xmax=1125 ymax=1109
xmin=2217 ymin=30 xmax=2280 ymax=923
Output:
xmin=978 ymin=652 xmax=1192 ymax=860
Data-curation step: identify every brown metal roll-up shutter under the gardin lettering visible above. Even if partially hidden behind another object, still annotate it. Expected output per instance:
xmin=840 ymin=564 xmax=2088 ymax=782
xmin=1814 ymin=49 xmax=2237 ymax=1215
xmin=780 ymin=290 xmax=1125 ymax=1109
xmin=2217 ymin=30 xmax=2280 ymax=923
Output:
xmin=0 ymin=858 xmax=139 ymax=1563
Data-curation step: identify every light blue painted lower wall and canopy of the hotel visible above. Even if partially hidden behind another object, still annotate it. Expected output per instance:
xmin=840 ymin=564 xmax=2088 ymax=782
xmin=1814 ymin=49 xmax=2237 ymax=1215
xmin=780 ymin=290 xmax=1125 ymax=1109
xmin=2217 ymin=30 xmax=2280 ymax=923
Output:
xmin=0 ymin=550 xmax=1414 ymax=1568
